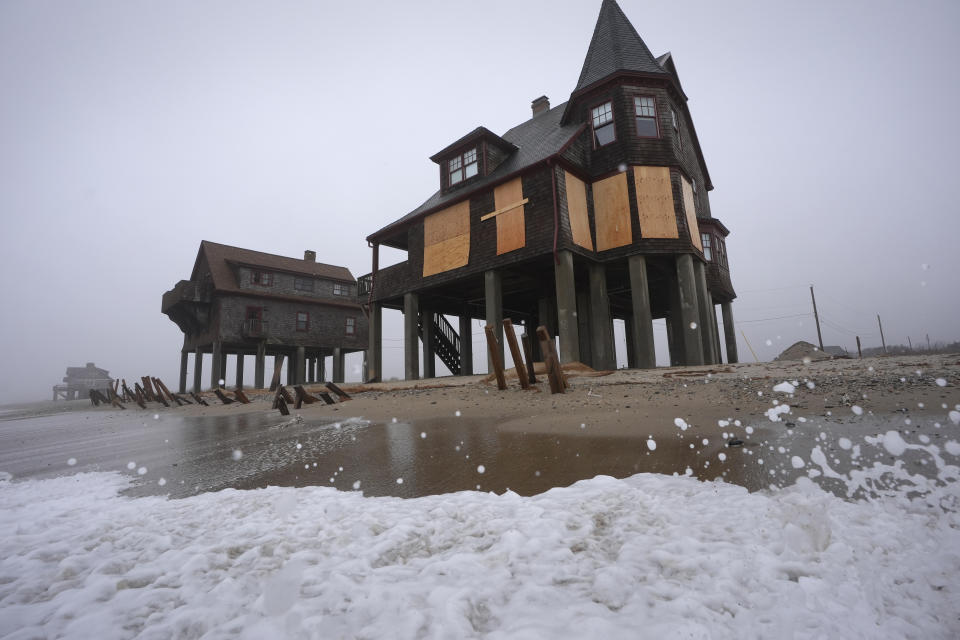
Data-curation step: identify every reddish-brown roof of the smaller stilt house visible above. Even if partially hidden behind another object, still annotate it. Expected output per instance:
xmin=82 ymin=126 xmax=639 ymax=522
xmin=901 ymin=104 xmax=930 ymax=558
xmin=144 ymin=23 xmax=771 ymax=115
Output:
xmin=190 ymin=240 xmax=354 ymax=291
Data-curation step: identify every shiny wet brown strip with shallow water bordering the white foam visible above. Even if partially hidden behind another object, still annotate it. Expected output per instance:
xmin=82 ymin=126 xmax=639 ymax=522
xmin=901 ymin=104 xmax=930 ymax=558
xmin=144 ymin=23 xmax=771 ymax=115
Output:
xmin=0 ymin=412 xmax=943 ymax=497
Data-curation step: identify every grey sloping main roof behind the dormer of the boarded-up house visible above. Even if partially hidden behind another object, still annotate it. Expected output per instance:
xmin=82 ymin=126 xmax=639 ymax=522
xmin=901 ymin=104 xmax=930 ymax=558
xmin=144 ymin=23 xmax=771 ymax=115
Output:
xmin=367 ymin=103 xmax=584 ymax=249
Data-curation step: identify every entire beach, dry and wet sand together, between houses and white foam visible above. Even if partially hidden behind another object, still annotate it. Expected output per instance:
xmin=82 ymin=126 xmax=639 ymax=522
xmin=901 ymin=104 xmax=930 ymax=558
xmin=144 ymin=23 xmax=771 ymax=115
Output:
xmin=0 ymin=355 xmax=960 ymax=497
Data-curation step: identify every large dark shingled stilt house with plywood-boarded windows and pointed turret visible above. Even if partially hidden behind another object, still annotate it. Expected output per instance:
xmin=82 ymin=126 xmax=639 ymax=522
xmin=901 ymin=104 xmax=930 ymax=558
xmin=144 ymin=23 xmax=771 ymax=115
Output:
xmin=359 ymin=0 xmax=737 ymax=378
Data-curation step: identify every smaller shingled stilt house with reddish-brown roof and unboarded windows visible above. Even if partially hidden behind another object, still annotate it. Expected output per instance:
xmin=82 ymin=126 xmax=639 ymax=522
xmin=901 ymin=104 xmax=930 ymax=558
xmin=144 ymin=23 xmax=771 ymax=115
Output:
xmin=161 ymin=240 xmax=367 ymax=393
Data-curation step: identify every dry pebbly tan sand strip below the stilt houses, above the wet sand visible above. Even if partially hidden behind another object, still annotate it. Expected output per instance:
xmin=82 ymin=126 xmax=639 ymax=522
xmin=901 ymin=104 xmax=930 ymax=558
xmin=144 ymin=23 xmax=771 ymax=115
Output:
xmin=167 ymin=354 xmax=960 ymax=436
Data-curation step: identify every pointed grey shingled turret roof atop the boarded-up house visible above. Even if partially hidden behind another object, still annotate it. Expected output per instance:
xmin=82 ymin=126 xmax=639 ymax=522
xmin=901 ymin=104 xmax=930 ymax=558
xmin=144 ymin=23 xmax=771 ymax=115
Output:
xmin=573 ymin=0 xmax=667 ymax=94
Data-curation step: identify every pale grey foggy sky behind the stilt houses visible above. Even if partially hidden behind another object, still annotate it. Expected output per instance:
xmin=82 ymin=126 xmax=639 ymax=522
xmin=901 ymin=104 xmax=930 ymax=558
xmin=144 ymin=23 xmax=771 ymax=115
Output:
xmin=0 ymin=0 xmax=960 ymax=402
